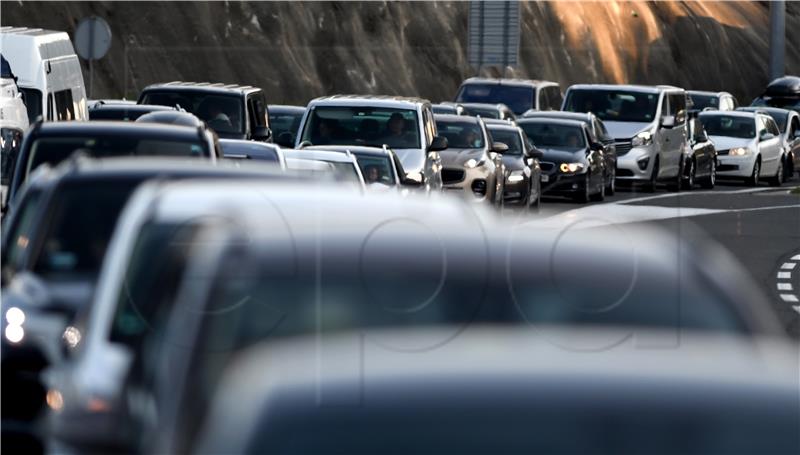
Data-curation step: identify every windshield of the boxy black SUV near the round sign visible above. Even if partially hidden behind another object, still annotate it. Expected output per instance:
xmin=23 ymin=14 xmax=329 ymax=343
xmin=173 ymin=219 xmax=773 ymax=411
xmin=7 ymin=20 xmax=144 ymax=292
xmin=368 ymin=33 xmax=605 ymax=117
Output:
xmin=139 ymin=90 xmax=245 ymax=135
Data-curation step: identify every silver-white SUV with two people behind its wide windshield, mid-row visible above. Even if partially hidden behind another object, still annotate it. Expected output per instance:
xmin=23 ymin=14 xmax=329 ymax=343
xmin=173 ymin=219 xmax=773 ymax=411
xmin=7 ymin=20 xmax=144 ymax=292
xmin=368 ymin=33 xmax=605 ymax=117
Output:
xmin=295 ymin=95 xmax=447 ymax=192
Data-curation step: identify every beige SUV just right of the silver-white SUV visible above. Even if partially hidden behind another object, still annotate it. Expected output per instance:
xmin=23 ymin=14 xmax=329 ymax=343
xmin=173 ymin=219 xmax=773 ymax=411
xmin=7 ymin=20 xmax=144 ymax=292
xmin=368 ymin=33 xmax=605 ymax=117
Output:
xmin=434 ymin=114 xmax=508 ymax=207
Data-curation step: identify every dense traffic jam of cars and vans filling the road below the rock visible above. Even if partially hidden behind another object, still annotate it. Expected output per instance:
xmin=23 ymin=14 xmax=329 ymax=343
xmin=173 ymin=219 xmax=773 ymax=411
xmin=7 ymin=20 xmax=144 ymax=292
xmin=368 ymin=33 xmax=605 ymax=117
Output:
xmin=0 ymin=10 xmax=800 ymax=454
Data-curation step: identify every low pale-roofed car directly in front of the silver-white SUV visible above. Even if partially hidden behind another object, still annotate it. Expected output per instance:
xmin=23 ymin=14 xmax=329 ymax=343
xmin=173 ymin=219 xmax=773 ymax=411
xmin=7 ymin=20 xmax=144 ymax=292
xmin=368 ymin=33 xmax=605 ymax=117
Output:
xmin=303 ymin=145 xmax=405 ymax=191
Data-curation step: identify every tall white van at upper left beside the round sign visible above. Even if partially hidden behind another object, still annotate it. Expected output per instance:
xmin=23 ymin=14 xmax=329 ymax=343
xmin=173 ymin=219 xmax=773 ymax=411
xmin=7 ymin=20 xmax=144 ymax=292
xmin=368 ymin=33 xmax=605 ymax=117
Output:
xmin=0 ymin=27 xmax=89 ymax=123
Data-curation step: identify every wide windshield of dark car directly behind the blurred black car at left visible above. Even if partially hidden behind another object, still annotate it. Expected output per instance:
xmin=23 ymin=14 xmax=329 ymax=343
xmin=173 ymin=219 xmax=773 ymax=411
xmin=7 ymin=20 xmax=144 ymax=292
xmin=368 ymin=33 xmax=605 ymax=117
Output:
xmin=23 ymin=134 xmax=210 ymax=183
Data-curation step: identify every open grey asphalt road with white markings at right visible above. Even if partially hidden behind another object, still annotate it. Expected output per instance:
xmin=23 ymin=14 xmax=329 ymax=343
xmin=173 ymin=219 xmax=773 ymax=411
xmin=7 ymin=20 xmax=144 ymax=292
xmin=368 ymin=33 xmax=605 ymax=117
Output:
xmin=540 ymin=181 xmax=800 ymax=338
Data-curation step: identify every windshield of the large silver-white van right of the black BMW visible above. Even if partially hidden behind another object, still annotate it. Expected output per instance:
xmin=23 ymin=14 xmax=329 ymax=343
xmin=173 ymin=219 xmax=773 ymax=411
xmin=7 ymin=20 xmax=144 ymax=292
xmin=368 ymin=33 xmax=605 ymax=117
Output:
xmin=564 ymin=89 xmax=658 ymax=123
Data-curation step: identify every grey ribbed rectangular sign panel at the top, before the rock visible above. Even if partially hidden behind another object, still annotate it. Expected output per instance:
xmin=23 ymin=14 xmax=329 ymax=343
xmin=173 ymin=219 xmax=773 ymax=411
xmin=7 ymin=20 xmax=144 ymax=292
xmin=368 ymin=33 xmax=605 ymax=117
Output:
xmin=468 ymin=1 xmax=520 ymax=70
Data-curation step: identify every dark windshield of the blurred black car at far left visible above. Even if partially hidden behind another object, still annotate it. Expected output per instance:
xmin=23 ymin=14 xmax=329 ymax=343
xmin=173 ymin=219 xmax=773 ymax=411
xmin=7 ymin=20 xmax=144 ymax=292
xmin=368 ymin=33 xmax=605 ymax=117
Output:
xmin=32 ymin=178 xmax=141 ymax=278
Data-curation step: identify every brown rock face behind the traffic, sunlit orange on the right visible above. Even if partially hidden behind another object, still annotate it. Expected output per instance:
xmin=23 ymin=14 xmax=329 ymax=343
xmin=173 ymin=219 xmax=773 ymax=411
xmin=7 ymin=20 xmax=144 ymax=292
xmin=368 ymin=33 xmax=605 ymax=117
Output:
xmin=2 ymin=1 xmax=800 ymax=104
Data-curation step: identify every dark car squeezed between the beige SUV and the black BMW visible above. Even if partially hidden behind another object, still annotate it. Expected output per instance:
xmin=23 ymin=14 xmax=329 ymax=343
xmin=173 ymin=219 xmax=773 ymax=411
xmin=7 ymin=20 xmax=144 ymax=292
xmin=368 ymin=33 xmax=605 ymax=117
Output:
xmin=486 ymin=122 xmax=544 ymax=210
